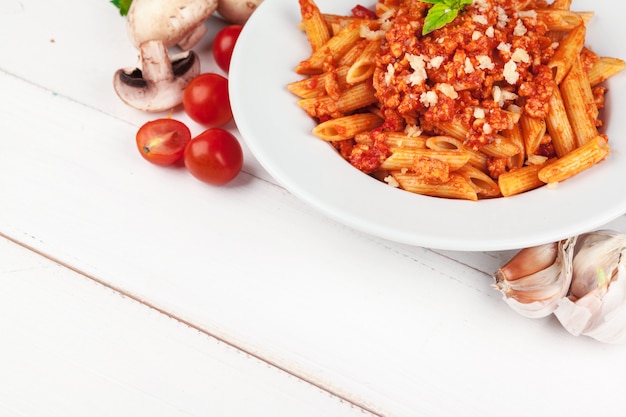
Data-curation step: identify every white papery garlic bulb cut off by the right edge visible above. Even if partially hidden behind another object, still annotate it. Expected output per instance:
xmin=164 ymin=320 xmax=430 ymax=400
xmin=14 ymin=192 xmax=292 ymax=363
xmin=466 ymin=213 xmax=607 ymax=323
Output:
xmin=554 ymin=230 xmax=626 ymax=343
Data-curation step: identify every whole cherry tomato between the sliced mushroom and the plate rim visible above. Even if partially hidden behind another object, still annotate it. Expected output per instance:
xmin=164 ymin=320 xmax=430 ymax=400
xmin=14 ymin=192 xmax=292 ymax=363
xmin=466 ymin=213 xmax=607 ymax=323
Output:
xmin=183 ymin=72 xmax=233 ymax=127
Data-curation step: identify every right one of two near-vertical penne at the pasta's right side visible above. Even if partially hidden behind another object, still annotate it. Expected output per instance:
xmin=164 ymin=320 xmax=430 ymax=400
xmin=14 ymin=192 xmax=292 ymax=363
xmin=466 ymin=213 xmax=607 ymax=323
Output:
xmin=559 ymin=59 xmax=598 ymax=146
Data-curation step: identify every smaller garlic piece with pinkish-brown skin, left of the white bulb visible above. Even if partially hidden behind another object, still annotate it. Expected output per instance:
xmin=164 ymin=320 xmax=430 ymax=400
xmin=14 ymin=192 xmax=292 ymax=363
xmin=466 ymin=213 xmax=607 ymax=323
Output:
xmin=494 ymin=238 xmax=576 ymax=318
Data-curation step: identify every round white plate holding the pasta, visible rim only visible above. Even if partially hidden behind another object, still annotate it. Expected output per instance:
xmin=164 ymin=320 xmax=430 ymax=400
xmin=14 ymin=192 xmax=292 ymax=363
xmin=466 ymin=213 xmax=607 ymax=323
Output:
xmin=229 ymin=0 xmax=626 ymax=251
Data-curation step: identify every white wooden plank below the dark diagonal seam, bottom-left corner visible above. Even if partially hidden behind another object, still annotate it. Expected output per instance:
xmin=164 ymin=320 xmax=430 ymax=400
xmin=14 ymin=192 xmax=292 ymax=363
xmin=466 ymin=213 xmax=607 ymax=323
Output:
xmin=0 ymin=234 xmax=370 ymax=417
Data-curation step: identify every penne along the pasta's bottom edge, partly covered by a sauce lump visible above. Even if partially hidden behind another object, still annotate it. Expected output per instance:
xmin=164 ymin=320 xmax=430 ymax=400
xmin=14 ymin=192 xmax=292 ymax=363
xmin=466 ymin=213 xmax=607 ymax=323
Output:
xmin=392 ymin=171 xmax=478 ymax=201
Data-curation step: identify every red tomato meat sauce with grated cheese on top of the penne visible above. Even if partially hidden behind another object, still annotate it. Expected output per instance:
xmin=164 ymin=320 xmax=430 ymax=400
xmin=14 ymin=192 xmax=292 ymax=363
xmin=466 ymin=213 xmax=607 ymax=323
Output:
xmin=330 ymin=0 xmax=605 ymax=179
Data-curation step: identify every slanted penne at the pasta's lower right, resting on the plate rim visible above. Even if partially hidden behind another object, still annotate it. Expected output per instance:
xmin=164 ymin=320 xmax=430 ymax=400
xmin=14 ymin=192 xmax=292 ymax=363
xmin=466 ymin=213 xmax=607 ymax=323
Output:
xmin=538 ymin=135 xmax=610 ymax=184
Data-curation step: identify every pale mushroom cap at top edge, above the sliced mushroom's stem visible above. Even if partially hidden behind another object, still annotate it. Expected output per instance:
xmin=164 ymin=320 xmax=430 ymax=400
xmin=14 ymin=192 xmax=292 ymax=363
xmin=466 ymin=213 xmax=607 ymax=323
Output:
xmin=126 ymin=0 xmax=217 ymax=48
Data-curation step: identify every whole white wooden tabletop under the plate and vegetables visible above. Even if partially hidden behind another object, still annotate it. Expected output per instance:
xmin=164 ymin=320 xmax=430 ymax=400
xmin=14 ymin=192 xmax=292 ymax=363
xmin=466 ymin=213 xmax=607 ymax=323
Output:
xmin=0 ymin=0 xmax=626 ymax=417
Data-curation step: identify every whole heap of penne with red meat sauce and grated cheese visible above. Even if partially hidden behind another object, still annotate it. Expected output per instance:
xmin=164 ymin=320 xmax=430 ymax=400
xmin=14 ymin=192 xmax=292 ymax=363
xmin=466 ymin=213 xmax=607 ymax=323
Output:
xmin=287 ymin=0 xmax=626 ymax=200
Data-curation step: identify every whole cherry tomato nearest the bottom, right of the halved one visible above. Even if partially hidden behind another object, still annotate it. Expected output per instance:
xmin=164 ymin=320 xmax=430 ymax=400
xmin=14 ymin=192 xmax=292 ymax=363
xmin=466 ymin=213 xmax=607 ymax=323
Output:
xmin=184 ymin=128 xmax=243 ymax=185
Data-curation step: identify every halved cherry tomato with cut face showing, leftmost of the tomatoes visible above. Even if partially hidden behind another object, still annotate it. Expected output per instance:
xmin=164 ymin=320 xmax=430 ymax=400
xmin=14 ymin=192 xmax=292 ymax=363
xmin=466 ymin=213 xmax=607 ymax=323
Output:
xmin=135 ymin=119 xmax=191 ymax=166
